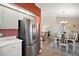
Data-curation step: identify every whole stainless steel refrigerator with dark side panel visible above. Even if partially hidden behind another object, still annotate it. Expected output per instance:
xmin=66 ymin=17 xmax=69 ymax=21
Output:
xmin=18 ymin=19 xmax=38 ymax=56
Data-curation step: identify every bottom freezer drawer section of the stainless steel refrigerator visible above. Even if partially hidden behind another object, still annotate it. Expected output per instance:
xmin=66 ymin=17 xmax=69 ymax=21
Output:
xmin=22 ymin=42 xmax=38 ymax=56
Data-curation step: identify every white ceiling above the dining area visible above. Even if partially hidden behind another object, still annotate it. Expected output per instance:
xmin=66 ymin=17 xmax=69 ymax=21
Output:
xmin=36 ymin=3 xmax=79 ymax=17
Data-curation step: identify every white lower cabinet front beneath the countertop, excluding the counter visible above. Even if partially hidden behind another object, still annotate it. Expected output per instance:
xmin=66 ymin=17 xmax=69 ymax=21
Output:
xmin=0 ymin=42 xmax=22 ymax=56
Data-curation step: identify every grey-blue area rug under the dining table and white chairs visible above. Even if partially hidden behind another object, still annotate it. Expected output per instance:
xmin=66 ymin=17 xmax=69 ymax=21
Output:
xmin=48 ymin=41 xmax=79 ymax=56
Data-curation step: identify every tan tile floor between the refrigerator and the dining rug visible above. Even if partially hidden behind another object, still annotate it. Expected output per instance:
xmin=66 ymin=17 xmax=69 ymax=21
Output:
xmin=38 ymin=39 xmax=63 ymax=56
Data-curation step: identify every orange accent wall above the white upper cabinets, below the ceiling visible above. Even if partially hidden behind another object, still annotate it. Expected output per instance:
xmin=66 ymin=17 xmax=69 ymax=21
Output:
xmin=15 ymin=3 xmax=41 ymax=16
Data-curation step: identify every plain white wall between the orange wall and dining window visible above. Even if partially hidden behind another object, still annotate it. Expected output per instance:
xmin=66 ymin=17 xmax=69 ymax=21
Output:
xmin=41 ymin=16 xmax=57 ymax=33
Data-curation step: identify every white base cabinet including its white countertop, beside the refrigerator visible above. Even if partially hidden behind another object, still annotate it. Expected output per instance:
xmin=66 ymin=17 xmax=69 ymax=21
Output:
xmin=0 ymin=37 xmax=22 ymax=56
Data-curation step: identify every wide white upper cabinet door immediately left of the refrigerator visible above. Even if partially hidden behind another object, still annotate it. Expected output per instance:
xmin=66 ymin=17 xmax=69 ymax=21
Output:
xmin=4 ymin=7 xmax=19 ymax=29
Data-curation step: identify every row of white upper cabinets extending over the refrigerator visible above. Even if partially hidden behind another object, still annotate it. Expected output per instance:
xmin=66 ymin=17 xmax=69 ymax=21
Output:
xmin=0 ymin=6 xmax=34 ymax=29
